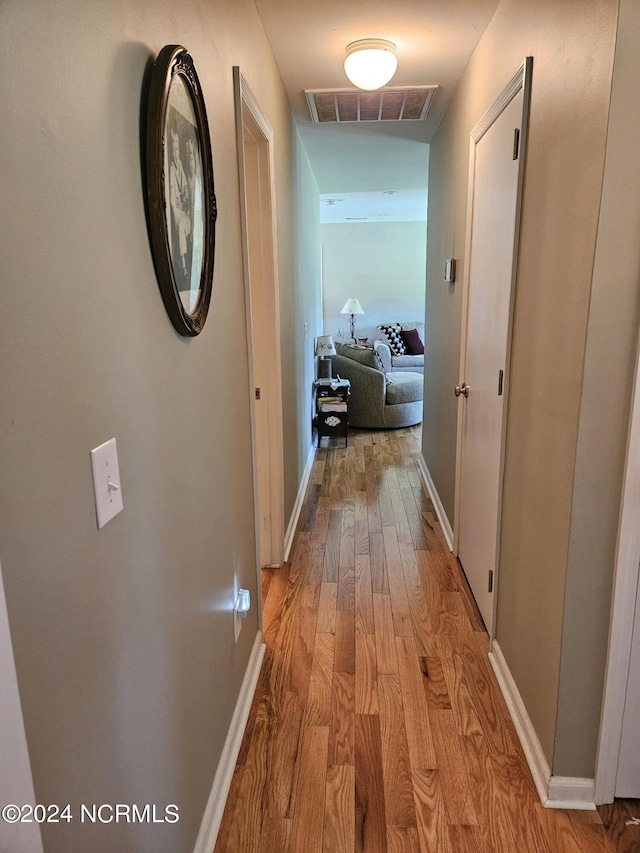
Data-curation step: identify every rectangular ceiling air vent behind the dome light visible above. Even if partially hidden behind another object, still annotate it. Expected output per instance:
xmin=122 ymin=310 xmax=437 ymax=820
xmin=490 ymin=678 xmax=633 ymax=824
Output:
xmin=305 ymin=86 xmax=438 ymax=124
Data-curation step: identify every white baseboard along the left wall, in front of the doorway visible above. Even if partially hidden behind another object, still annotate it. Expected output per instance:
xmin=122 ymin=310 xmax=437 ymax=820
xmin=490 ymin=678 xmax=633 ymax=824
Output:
xmin=193 ymin=631 xmax=266 ymax=853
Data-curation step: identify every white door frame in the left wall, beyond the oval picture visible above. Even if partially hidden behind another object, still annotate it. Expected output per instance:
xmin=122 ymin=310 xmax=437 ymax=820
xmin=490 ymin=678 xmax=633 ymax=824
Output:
xmin=233 ymin=66 xmax=284 ymax=590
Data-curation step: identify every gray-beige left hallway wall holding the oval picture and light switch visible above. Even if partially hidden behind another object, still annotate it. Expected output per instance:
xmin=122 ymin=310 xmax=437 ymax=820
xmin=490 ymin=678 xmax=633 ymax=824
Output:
xmin=0 ymin=0 xmax=319 ymax=853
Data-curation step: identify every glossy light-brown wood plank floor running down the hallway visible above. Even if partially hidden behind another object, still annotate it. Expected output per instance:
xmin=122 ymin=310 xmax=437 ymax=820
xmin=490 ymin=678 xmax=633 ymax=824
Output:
xmin=215 ymin=427 xmax=615 ymax=853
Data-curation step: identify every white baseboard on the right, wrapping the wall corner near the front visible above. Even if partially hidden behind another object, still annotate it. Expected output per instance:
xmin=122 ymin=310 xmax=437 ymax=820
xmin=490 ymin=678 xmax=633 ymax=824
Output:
xmin=489 ymin=640 xmax=596 ymax=810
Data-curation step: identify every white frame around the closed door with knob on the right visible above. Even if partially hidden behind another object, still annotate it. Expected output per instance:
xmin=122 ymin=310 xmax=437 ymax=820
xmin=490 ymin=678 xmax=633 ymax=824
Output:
xmin=451 ymin=56 xmax=533 ymax=639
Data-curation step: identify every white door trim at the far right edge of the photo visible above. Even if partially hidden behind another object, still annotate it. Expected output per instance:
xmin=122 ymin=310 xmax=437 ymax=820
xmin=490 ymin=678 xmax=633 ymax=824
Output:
xmin=594 ymin=330 xmax=640 ymax=805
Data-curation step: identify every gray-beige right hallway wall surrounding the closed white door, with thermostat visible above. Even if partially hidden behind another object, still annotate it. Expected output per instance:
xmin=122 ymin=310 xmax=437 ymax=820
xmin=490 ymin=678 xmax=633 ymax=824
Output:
xmin=423 ymin=0 xmax=631 ymax=776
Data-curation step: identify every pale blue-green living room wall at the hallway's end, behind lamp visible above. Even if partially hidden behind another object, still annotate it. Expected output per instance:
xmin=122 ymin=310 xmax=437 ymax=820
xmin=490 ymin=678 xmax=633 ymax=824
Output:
xmin=320 ymin=222 xmax=427 ymax=340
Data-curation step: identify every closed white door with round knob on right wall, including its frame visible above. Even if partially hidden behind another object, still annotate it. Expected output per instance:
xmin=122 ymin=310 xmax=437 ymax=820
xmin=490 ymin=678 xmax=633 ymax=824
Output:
xmin=456 ymin=61 xmax=530 ymax=634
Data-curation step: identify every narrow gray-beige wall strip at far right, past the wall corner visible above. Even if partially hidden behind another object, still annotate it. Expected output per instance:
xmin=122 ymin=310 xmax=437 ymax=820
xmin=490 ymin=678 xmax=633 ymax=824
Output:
xmin=554 ymin=0 xmax=640 ymax=776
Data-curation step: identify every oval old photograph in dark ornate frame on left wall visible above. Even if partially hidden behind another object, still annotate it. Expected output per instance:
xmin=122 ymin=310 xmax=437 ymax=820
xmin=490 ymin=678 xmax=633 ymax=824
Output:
xmin=146 ymin=44 xmax=217 ymax=337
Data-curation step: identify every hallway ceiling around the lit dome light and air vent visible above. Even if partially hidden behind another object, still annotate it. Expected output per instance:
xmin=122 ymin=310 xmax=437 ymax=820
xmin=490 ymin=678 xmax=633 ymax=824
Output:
xmin=256 ymin=0 xmax=499 ymax=201
